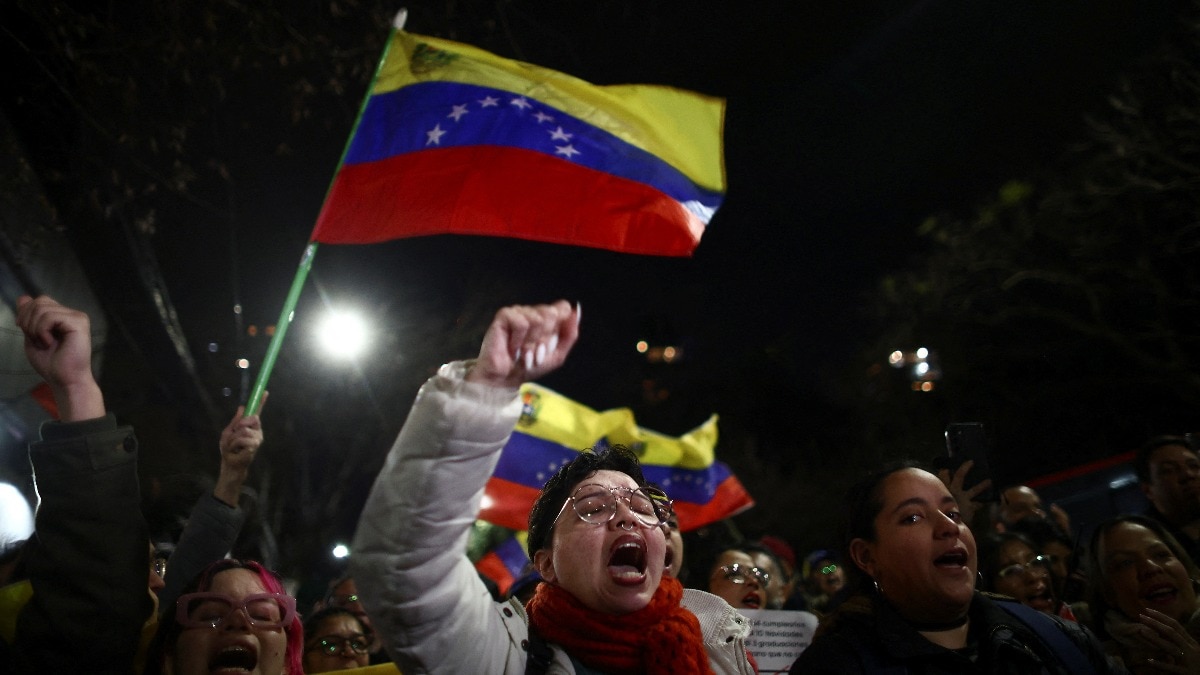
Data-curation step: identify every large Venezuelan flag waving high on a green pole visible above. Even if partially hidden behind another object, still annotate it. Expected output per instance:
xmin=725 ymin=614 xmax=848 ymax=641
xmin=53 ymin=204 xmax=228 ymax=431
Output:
xmin=312 ymin=31 xmax=725 ymax=256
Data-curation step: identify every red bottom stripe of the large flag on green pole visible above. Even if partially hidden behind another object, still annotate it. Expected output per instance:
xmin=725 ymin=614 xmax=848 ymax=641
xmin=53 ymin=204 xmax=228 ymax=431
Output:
xmin=312 ymin=145 xmax=704 ymax=256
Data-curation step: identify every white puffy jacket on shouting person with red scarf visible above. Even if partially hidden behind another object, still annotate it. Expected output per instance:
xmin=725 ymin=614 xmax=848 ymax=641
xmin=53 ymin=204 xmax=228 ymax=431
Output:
xmin=350 ymin=362 xmax=754 ymax=675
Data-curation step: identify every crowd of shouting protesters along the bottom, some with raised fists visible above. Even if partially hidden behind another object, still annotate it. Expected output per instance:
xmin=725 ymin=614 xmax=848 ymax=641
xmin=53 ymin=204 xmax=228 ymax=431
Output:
xmin=7 ymin=297 xmax=1200 ymax=675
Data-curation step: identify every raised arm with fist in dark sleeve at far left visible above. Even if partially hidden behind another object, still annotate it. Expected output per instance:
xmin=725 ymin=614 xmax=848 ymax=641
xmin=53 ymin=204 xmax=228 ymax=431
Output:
xmin=13 ymin=297 xmax=152 ymax=673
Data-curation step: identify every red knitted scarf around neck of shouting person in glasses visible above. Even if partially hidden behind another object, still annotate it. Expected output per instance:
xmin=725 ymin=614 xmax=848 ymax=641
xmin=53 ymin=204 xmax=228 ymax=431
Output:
xmin=526 ymin=575 xmax=713 ymax=675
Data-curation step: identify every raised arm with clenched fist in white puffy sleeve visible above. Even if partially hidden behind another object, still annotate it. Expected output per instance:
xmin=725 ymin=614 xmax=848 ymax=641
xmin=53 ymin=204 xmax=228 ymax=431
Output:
xmin=350 ymin=301 xmax=580 ymax=673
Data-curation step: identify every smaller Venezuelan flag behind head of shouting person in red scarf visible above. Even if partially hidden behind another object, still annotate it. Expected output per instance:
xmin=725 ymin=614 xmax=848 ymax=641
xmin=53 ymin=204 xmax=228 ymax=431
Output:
xmin=479 ymin=383 xmax=754 ymax=530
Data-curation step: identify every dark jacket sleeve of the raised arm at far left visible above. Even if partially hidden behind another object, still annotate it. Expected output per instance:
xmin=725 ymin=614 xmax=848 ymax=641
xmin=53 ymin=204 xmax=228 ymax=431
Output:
xmin=12 ymin=414 xmax=154 ymax=673
